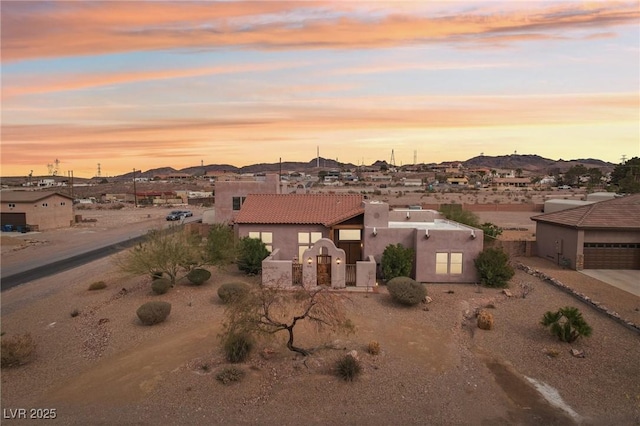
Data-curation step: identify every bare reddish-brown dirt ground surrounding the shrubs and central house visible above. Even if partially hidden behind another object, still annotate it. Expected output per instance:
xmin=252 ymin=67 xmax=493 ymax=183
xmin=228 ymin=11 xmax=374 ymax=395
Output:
xmin=2 ymin=198 xmax=640 ymax=425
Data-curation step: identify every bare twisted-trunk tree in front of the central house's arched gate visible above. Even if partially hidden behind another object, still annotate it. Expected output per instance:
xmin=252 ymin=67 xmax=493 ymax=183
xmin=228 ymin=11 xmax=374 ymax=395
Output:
xmin=223 ymin=287 xmax=353 ymax=356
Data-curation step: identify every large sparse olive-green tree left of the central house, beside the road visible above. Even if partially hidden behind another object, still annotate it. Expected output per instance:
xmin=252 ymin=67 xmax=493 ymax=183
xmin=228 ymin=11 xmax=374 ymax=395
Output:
xmin=116 ymin=226 xmax=206 ymax=285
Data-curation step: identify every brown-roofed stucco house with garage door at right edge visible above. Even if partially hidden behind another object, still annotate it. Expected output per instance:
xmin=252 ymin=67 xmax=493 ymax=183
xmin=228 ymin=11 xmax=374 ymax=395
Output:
xmin=531 ymin=194 xmax=640 ymax=270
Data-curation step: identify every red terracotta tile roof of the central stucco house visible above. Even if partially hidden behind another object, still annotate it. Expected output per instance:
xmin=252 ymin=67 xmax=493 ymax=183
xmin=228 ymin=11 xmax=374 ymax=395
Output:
xmin=235 ymin=194 xmax=364 ymax=226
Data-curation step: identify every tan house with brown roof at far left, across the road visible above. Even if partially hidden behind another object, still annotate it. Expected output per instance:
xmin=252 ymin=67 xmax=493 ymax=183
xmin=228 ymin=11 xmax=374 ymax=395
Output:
xmin=0 ymin=191 xmax=74 ymax=231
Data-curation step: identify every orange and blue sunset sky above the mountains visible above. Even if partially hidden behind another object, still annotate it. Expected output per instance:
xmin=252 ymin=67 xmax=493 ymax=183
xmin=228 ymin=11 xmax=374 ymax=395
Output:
xmin=0 ymin=0 xmax=640 ymax=177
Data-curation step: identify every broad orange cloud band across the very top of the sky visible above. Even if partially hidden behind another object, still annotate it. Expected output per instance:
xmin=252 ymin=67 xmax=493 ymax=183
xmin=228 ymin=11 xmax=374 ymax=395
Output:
xmin=2 ymin=2 xmax=640 ymax=61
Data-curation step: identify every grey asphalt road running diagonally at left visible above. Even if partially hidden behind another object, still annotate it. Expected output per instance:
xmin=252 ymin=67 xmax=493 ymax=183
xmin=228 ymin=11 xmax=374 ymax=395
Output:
xmin=0 ymin=216 xmax=201 ymax=291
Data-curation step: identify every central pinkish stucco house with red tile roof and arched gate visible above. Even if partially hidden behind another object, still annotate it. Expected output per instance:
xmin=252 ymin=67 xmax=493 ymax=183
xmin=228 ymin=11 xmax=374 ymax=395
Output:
xmin=234 ymin=194 xmax=483 ymax=288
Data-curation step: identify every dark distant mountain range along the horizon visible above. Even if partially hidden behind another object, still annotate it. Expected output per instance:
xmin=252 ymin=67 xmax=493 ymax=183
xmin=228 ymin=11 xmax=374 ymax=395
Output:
xmin=122 ymin=154 xmax=616 ymax=178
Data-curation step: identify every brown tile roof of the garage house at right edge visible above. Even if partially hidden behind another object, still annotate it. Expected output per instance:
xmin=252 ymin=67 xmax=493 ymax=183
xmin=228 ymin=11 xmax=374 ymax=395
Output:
xmin=531 ymin=194 xmax=640 ymax=230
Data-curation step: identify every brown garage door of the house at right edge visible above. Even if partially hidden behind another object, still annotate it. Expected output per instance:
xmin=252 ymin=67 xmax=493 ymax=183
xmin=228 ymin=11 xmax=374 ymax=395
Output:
xmin=583 ymin=243 xmax=640 ymax=269
